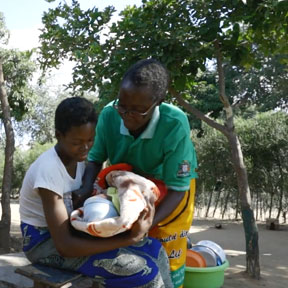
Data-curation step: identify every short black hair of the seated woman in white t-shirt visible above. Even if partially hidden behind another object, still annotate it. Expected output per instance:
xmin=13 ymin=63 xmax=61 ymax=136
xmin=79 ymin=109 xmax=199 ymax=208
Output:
xmin=55 ymin=97 xmax=97 ymax=134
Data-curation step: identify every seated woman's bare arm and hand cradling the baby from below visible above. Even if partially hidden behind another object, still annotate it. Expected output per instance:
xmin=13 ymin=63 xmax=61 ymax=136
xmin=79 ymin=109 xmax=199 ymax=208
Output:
xmin=39 ymin=188 xmax=154 ymax=257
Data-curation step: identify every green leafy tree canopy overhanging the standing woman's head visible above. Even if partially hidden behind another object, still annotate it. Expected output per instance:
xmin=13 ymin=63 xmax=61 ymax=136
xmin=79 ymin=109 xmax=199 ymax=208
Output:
xmin=40 ymin=0 xmax=288 ymax=112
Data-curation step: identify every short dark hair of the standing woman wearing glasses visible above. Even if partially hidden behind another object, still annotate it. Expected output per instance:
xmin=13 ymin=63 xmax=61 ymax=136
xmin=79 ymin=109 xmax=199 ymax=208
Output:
xmin=122 ymin=59 xmax=170 ymax=101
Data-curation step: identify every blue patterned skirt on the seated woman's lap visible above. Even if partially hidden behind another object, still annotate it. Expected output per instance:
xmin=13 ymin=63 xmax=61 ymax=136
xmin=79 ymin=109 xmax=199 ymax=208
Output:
xmin=21 ymin=223 xmax=173 ymax=288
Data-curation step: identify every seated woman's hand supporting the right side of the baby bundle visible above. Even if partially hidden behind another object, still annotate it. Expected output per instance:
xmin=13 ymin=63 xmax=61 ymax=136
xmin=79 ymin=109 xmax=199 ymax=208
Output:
xmin=129 ymin=201 xmax=155 ymax=244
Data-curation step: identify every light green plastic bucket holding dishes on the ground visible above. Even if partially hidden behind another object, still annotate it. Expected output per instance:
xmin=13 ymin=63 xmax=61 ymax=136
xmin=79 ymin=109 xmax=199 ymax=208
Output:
xmin=184 ymin=260 xmax=229 ymax=288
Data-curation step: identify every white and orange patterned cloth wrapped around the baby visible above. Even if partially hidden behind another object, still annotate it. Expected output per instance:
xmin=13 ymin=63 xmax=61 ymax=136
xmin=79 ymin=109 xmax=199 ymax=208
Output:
xmin=70 ymin=170 xmax=160 ymax=237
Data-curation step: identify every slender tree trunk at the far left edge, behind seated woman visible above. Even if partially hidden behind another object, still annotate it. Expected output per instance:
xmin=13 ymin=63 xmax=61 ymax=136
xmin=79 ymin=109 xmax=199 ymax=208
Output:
xmin=0 ymin=58 xmax=14 ymax=251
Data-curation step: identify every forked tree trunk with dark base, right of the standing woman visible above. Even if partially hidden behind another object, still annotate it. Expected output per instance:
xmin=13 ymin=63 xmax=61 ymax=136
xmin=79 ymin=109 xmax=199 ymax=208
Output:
xmin=170 ymin=40 xmax=260 ymax=279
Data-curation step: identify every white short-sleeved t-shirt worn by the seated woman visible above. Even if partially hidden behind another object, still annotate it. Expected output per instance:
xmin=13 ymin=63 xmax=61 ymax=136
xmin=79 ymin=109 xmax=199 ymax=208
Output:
xmin=20 ymin=147 xmax=85 ymax=227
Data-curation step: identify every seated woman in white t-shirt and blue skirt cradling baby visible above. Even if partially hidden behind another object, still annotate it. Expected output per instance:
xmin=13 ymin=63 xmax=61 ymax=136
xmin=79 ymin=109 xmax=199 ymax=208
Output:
xmin=20 ymin=97 xmax=173 ymax=288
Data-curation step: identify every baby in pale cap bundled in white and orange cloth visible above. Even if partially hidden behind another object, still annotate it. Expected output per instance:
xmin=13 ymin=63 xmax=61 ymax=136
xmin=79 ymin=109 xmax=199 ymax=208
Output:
xmin=70 ymin=170 xmax=160 ymax=237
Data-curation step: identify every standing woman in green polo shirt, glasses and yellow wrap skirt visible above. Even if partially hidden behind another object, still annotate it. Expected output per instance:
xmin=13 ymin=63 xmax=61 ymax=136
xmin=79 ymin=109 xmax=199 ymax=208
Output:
xmin=80 ymin=59 xmax=197 ymax=287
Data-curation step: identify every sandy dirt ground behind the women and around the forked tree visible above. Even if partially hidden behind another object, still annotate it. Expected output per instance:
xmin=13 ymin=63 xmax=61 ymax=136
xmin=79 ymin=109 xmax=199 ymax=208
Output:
xmin=0 ymin=201 xmax=288 ymax=288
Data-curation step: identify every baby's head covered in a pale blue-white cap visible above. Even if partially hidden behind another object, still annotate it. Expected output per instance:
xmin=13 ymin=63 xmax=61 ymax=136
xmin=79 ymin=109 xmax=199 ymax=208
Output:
xmin=83 ymin=194 xmax=119 ymax=222
